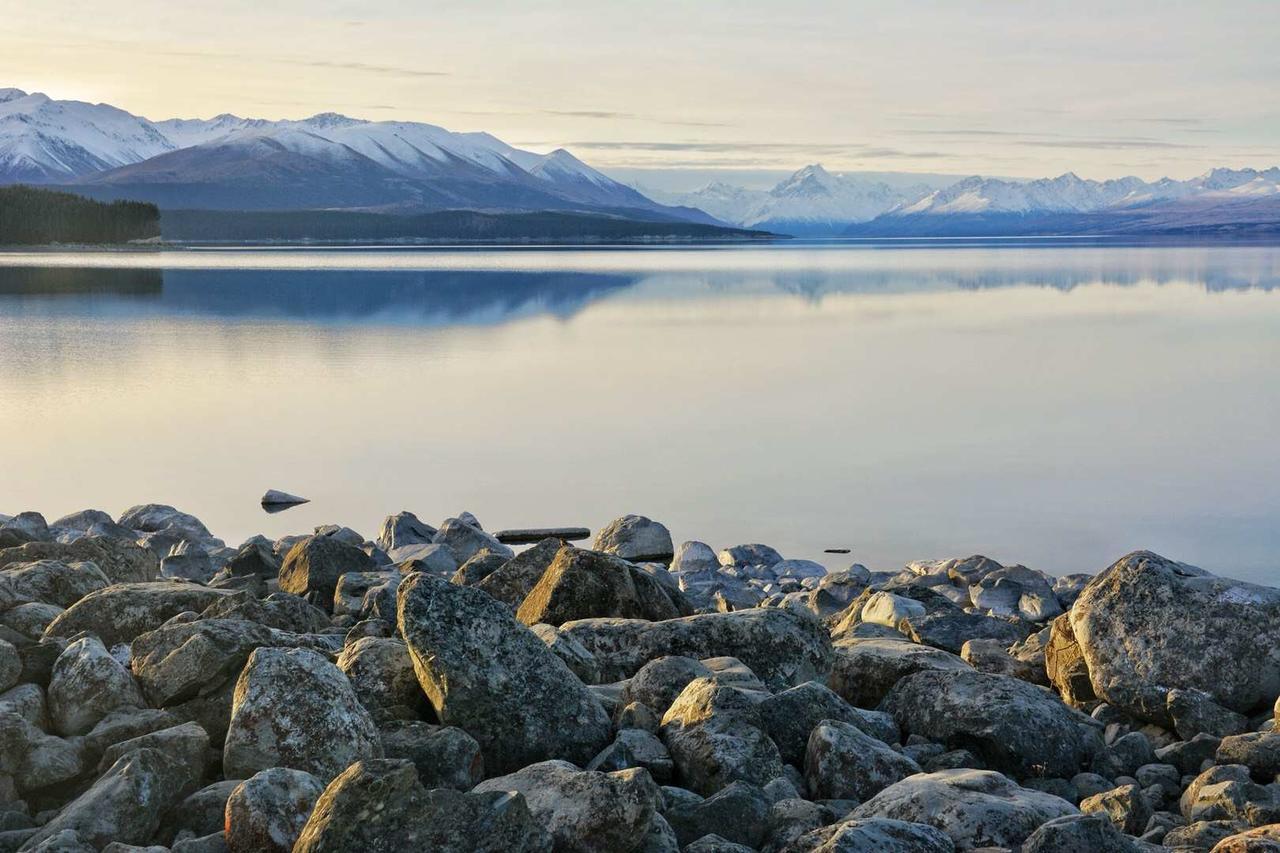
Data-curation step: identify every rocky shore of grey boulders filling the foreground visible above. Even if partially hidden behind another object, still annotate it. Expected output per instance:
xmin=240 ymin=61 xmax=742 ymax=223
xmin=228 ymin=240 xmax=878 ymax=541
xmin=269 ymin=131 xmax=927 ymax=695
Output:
xmin=0 ymin=505 xmax=1280 ymax=853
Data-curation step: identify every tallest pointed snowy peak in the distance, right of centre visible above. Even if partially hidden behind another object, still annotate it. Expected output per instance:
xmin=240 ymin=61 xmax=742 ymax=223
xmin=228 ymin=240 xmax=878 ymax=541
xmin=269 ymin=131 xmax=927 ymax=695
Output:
xmin=680 ymin=164 xmax=929 ymax=234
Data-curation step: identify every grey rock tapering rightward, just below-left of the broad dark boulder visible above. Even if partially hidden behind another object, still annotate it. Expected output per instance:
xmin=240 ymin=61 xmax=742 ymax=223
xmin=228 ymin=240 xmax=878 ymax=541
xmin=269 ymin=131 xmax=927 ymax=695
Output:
xmin=804 ymin=720 xmax=920 ymax=800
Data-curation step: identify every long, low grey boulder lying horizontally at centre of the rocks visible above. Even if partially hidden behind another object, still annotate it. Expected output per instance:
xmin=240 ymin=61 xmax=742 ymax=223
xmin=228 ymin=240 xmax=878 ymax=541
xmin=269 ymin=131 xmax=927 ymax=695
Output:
xmin=561 ymin=608 xmax=832 ymax=690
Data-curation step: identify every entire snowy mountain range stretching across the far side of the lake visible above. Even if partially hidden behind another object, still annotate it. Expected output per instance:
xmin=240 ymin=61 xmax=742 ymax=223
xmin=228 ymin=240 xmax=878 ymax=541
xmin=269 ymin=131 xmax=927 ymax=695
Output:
xmin=0 ymin=88 xmax=1280 ymax=237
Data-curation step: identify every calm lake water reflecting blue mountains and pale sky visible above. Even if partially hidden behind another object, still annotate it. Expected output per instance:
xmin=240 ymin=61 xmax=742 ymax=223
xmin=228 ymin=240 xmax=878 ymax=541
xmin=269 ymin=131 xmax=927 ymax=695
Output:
xmin=0 ymin=243 xmax=1280 ymax=584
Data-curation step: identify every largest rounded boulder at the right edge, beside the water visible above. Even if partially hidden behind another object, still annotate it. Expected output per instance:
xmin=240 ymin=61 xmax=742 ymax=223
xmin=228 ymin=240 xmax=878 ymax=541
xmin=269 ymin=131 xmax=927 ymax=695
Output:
xmin=1070 ymin=551 xmax=1280 ymax=726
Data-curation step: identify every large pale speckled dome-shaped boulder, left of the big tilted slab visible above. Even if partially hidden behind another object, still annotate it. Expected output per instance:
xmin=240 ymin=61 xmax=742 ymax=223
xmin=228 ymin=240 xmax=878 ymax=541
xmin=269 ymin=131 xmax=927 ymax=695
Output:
xmin=223 ymin=648 xmax=381 ymax=781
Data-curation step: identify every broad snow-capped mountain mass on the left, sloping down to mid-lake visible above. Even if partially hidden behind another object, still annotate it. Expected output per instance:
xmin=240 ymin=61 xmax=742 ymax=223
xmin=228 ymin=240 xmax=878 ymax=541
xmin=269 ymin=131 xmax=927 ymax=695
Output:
xmin=0 ymin=90 xmax=713 ymax=222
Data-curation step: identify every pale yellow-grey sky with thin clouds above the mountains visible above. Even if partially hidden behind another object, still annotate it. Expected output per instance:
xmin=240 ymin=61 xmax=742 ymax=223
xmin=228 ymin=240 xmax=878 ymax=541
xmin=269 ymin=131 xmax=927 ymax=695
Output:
xmin=0 ymin=0 xmax=1280 ymax=183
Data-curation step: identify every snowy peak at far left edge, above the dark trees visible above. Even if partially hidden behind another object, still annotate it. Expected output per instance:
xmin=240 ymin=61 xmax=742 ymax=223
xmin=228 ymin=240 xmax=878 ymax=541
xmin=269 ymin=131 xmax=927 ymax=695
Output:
xmin=0 ymin=88 xmax=175 ymax=183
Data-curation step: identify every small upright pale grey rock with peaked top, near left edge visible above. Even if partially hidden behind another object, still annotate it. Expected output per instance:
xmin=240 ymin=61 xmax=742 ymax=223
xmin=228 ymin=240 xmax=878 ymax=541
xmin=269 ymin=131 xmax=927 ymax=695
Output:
xmin=49 ymin=637 xmax=147 ymax=735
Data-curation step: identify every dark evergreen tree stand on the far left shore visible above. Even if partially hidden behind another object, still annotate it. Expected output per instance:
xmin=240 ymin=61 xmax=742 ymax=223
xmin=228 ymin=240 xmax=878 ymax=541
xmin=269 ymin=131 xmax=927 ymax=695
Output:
xmin=0 ymin=184 xmax=160 ymax=246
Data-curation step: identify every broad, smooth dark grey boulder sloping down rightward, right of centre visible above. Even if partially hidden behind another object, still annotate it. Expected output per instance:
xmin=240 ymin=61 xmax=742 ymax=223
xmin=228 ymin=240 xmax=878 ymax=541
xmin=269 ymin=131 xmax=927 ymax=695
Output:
xmin=884 ymin=670 xmax=1102 ymax=779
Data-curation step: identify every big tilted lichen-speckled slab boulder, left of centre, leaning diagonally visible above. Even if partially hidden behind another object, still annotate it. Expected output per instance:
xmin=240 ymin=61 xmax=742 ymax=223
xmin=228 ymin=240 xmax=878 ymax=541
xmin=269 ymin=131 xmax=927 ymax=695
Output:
xmin=397 ymin=573 xmax=612 ymax=774
